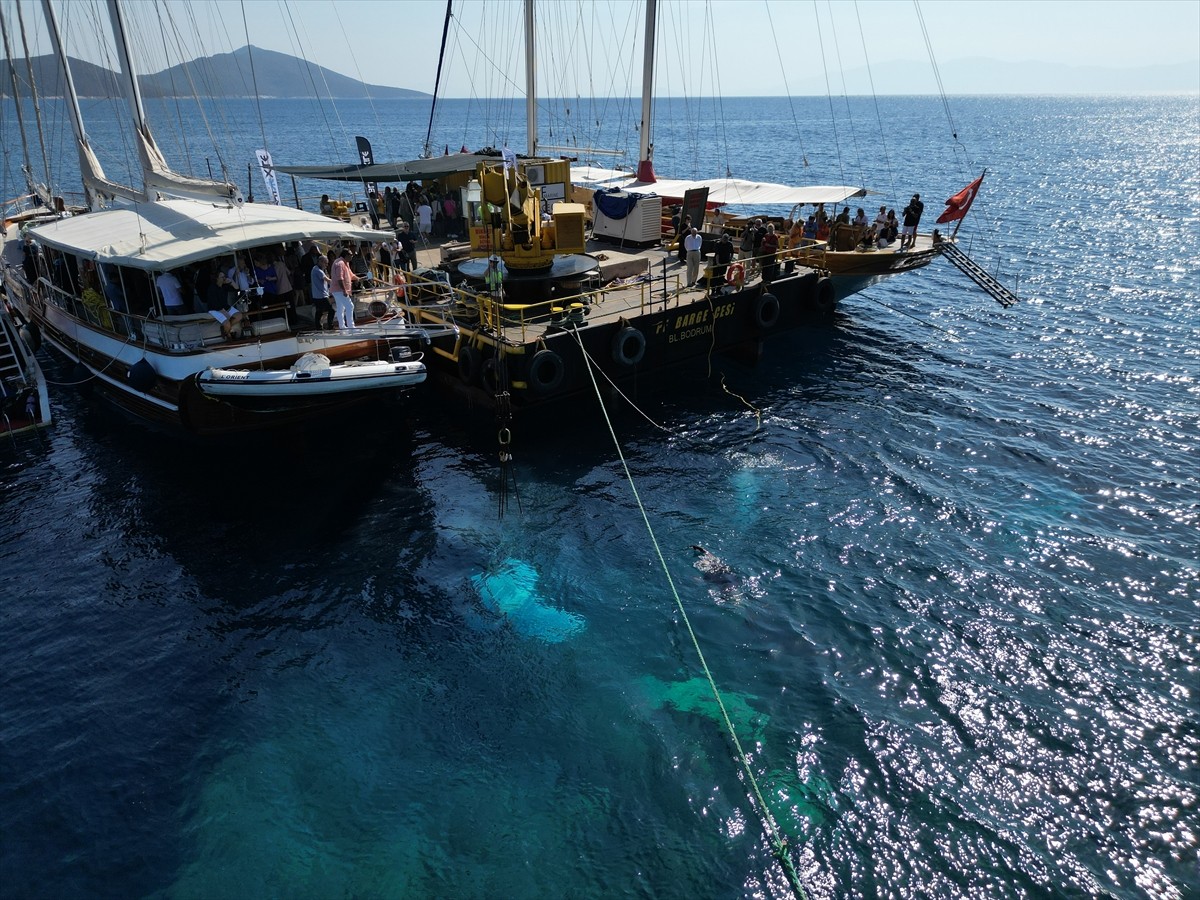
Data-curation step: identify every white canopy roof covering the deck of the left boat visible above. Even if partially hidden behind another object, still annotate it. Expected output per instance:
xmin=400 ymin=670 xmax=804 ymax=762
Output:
xmin=31 ymin=200 xmax=391 ymax=271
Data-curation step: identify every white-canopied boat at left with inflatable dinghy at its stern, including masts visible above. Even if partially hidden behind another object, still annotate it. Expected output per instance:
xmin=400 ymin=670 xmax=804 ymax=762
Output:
xmin=4 ymin=2 xmax=428 ymax=434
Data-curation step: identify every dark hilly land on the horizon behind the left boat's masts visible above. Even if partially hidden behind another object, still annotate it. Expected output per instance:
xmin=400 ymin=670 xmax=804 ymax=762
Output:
xmin=0 ymin=47 xmax=431 ymax=100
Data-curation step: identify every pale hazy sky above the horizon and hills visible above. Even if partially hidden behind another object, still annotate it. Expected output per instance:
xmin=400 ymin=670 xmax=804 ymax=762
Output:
xmin=16 ymin=0 xmax=1200 ymax=97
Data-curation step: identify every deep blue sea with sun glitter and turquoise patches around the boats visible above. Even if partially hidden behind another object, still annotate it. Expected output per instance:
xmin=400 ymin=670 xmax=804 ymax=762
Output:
xmin=0 ymin=96 xmax=1200 ymax=900
